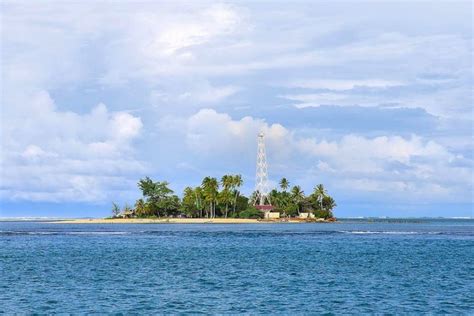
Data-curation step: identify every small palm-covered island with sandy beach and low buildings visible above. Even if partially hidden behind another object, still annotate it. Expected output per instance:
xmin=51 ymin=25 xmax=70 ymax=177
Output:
xmin=61 ymin=174 xmax=336 ymax=224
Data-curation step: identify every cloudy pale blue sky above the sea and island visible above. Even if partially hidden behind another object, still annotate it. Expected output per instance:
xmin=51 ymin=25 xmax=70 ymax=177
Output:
xmin=0 ymin=1 xmax=474 ymax=217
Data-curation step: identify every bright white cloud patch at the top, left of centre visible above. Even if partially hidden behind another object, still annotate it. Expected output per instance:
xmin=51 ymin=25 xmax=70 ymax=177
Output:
xmin=100 ymin=4 xmax=247 ymax=85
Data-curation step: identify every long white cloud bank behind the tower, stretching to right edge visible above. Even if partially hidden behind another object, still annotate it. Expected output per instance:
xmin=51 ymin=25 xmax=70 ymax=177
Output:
xmin=160 ymin=109 xmax=472 ymax=201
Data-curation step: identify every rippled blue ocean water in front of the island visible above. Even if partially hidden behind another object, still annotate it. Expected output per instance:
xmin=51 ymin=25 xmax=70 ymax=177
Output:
xmin=0 ymin=219 xmax=474 ymax=314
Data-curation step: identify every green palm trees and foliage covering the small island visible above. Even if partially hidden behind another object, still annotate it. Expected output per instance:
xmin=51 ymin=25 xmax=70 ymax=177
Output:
xmin=120 ymin=175 xmax=336 ymax=218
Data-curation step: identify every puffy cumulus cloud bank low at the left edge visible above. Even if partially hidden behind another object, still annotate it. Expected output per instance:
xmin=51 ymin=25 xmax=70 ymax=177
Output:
xmin=1 ymin=91 xmax=146 ymax=202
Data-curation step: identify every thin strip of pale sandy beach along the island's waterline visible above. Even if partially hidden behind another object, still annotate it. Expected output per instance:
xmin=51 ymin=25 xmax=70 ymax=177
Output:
xmin=51 ymin=218 xmax=330 ymax=224
